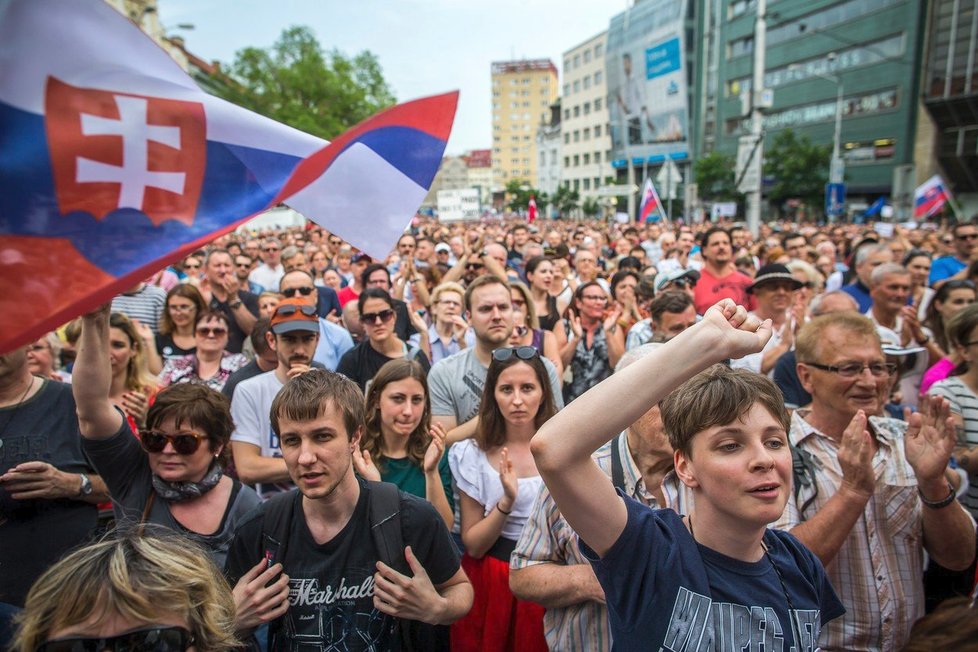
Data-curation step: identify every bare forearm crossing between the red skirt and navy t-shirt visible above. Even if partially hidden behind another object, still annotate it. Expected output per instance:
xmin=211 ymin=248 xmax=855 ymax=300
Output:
xmin=509 ymin=563 xmax=603 ymax=609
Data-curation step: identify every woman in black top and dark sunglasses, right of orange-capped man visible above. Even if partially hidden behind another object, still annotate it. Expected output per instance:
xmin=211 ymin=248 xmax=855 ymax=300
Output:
xmin=336 ymin=287 xmax=431 ymax=391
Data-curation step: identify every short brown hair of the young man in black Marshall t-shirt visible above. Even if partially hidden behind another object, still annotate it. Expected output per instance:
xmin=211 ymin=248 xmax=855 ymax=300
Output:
xmin=271 ymin=369 xmax=363 ymax=439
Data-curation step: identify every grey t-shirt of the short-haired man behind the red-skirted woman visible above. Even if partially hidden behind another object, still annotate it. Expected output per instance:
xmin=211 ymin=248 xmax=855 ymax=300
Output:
xmin=428 ymin=348 xmax=564 ymax=424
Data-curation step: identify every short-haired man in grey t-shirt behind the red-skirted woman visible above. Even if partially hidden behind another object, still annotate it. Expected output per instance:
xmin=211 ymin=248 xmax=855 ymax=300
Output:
xmin=428 ymin=275 xmax=563 ymax=443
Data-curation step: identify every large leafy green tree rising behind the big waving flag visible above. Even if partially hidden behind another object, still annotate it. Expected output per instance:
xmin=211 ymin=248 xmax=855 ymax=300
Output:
xmin=218 ymin=27 xmax=394 ymax=139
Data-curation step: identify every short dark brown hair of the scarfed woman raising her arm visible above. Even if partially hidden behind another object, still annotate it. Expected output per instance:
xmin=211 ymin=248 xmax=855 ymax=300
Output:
xmin=146 ymin=383 xmax=234 ymax=465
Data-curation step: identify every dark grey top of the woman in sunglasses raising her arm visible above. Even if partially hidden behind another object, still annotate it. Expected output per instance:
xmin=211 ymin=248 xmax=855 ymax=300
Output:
xmin=82 ymin=421 xmax=261 ymax=568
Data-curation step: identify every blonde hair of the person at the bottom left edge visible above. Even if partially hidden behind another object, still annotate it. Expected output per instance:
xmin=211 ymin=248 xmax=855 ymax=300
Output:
xmin=10 ymin=529 xmax=240 ymax=652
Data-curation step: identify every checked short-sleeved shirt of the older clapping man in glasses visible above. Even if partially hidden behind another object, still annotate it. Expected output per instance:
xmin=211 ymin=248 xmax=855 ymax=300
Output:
xmin=773 ymin=410 xmax=924 ymax=652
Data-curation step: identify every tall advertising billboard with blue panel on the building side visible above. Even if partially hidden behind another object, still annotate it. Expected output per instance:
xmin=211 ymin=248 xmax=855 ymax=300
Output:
xmin=605 ymin=0 xmax=689 ymax=166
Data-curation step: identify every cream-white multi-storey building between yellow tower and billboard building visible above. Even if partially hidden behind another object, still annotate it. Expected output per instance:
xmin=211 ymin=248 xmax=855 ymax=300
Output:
xmin=556 ymin=31 xmax=615 ymax=203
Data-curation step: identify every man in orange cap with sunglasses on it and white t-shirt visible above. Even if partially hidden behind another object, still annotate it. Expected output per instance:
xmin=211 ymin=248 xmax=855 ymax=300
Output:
xmin=231 ymin=297 xmax=319 ymax=499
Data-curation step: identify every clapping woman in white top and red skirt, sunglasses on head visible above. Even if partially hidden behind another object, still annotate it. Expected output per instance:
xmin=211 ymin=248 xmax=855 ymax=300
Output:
xmin=448 ymin=346 xmax=557 ymax=651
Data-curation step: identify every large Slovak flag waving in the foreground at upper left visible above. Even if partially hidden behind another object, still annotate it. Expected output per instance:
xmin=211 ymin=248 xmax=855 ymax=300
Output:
xmin=0 ymin=0 xmax=458 ymax=353
